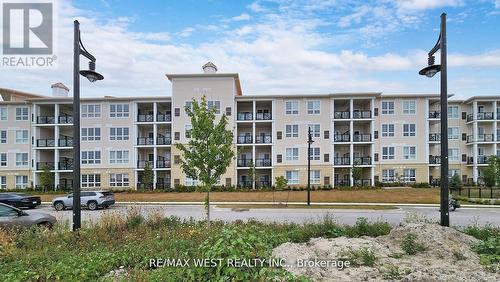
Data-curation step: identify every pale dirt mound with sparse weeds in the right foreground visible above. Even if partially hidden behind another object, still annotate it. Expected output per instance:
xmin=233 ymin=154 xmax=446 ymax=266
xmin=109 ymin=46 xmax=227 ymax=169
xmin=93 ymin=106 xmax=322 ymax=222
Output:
xmin=273 ymin=223 xmax=500 ymax=281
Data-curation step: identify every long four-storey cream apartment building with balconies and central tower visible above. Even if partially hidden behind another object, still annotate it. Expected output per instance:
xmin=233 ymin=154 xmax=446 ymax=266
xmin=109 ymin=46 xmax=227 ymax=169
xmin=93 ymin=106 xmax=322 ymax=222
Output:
xmin=0 ymin=63 xmax=500 ymax=189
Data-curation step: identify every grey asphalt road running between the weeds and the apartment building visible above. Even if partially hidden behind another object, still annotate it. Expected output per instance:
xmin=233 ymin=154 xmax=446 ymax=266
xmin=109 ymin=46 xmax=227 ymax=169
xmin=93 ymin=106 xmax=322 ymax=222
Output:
xmin=31 ymin=205 xmax=500 ymax=226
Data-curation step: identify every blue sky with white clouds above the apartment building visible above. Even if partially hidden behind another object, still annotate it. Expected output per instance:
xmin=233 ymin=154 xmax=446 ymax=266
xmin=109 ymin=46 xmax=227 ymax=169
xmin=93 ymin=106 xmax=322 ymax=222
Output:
xmin=0 ymin=0 xmax=500 ymax=98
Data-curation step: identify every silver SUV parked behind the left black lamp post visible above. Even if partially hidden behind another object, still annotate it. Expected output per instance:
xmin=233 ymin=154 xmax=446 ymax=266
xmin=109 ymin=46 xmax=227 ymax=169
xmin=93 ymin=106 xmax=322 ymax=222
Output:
xmin=52 ymin=191 xmax=115 ymax=211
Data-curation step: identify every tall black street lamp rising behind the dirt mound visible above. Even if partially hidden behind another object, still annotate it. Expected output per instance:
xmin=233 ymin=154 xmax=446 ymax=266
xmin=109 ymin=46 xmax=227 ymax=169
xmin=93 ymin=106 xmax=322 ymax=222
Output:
xmin=419 ymin=13 xmax=450 ymax=226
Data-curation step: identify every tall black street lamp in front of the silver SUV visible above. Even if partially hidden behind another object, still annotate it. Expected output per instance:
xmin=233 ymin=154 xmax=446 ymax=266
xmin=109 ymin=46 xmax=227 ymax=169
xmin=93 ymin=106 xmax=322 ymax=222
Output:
xmin=73 ymin=20 xmax=104 ymax=231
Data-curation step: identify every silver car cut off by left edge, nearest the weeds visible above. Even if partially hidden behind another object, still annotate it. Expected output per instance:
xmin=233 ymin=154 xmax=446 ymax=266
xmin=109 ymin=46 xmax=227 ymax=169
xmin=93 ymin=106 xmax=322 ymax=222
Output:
xmin=0 ymin=203 xmax=56 ymax=228
